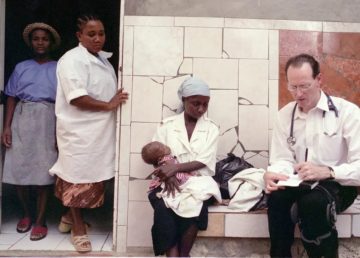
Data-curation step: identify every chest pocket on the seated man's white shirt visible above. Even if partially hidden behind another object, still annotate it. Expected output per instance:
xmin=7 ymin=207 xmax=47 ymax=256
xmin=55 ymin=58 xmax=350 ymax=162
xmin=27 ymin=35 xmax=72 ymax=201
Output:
xmin=315 ymin=134 xmax=346 ymax=163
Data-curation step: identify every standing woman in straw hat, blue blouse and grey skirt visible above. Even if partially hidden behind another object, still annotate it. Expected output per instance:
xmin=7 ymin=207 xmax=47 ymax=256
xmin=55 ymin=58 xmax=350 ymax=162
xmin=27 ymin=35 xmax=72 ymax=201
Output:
xmin=1 ymin=23 xmax=60 ymax=240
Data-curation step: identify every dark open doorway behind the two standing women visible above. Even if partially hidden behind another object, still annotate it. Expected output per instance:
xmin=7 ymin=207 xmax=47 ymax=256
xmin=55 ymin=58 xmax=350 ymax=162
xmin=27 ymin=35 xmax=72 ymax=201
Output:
xmin=0 ymin=0 xmax=120 ymax=251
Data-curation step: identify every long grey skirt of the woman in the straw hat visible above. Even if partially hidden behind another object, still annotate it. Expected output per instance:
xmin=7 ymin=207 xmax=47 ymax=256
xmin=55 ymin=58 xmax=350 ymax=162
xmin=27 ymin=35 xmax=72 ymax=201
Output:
xmin=3 ymin=101 xmax=57 ymax=185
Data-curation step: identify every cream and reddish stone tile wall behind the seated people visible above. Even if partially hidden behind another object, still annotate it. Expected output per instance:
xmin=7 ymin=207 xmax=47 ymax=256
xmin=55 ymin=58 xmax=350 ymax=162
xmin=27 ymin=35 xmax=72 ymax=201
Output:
xmin=114 ymin=16 xmax=360 ymax=250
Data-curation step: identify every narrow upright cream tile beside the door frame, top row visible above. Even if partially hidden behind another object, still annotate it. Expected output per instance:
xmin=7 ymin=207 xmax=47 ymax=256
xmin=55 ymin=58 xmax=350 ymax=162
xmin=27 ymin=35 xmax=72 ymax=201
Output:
xmin=122 ymin=26 xmax=134 ymax=75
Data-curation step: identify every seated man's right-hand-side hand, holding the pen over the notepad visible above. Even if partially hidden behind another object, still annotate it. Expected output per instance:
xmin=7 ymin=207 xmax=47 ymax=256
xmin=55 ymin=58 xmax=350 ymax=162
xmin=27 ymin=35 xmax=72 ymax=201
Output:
xmin=294 ymin=162 xmax=331 ymax=181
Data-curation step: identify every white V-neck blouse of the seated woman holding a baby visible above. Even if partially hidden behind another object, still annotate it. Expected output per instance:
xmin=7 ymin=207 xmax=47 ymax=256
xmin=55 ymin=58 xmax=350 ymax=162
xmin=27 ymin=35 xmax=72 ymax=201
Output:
xmin=153 ymin=112 xmax=219 ymax=176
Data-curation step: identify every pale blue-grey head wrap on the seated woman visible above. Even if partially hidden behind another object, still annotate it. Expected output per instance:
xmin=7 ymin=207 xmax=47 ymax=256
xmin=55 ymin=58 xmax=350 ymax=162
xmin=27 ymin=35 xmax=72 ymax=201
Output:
xmin=178 ymin=77 xmax=210 ymax=100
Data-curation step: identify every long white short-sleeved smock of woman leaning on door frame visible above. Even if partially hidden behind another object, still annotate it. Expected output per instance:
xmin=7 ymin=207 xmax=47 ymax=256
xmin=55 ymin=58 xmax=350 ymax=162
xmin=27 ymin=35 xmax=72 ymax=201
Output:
xmin=50 ymin=44 xmax=117 ymax=184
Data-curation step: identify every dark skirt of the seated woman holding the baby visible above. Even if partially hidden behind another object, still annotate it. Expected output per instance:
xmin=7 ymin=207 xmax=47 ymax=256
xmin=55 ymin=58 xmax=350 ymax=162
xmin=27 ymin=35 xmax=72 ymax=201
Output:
xmin=148 ymin=187 xmax=208 ymax=256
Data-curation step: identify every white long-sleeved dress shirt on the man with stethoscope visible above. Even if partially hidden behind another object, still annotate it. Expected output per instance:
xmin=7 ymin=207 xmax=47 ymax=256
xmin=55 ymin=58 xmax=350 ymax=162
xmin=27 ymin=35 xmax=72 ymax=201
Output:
xmin=268 ymin=92 xmax=360 ymax=186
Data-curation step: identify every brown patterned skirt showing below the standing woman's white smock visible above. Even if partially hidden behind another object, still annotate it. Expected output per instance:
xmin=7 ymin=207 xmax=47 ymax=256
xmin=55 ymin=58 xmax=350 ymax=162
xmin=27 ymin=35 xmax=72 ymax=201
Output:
xmin=55 ymin=177 xmax=105 ymax=208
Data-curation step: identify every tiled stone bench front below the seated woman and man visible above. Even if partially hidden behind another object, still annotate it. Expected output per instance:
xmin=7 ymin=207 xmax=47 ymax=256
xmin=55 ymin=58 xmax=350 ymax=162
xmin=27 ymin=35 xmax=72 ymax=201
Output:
xmin=198 ymin=196 xmax=360 ymax=238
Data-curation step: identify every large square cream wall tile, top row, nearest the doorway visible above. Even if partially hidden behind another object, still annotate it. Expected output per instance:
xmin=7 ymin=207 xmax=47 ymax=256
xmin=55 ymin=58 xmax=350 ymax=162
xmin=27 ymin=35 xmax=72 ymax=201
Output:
xmin=133 ymin=27 xmax=184 ymax=76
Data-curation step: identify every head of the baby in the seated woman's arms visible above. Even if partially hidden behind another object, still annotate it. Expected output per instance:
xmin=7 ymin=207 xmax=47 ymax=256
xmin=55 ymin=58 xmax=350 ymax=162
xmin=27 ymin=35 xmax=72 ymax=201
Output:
xmin=141 ymin=141 xmax=171 ymax=166
